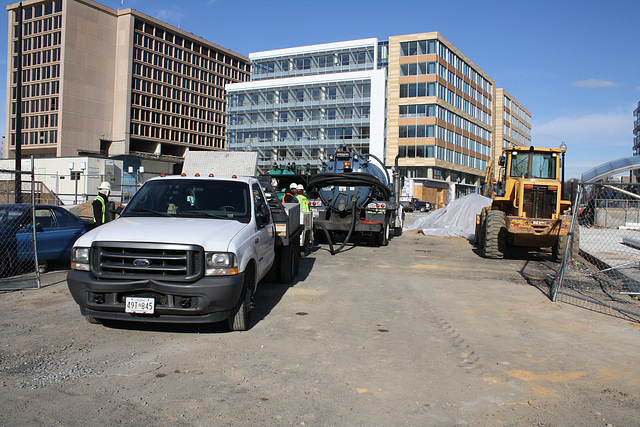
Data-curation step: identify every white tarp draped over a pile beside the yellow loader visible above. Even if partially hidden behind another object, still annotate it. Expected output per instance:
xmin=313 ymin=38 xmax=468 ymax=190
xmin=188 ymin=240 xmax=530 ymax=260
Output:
xmin=405 ymin=194 xmax=491 ymax=240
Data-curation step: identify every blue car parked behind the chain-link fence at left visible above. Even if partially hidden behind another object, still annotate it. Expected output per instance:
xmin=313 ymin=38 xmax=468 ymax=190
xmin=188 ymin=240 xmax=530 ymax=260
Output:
xmin=0 ymin=204 xmax=91 ymax=277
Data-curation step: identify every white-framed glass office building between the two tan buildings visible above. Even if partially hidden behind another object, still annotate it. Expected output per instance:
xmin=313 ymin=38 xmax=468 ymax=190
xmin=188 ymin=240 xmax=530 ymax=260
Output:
xmin=226 ymin=39 xmax=387 ymax=172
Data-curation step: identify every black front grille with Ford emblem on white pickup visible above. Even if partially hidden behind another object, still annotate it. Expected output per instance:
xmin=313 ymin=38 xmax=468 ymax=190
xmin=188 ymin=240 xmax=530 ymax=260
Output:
xmin=91 ymin=242 xmax=204 ymax=282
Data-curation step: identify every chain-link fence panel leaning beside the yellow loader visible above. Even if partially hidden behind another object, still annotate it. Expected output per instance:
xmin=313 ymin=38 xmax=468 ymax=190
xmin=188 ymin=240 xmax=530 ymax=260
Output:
xmin=551 ymin=183 xmax=640 ymax=321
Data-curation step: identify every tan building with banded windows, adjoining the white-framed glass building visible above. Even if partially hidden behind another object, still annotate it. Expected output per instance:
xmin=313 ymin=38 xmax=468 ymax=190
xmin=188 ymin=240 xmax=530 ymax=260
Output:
xmin=387 ymin=32 xmax=512 ymax=205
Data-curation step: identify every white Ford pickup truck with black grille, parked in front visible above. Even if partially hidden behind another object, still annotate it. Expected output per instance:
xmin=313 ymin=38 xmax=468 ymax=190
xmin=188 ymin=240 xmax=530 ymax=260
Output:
xmin=67 ymin=174 xmax=300 ymax=330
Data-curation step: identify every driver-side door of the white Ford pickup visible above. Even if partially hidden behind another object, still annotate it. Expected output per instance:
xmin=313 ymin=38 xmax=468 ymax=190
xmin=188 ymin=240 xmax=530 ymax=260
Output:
xmin=251 ymin=183 xmax=275 ymax=278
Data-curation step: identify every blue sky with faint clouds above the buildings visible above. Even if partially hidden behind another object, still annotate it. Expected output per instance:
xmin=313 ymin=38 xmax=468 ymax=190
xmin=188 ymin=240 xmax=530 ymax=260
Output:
xmin=0 ymin=0 xmax=640 ymax=178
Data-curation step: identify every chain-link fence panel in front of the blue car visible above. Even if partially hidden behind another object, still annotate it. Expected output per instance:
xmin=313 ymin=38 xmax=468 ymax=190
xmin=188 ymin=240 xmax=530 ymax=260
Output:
xmin=0 ymin=169 xmax=40 ymax=291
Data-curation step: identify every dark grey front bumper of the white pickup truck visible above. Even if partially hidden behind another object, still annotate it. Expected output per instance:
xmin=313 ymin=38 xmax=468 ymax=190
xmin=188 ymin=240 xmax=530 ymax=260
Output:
xmin=67 ymin=270 xmax=244 ymax=323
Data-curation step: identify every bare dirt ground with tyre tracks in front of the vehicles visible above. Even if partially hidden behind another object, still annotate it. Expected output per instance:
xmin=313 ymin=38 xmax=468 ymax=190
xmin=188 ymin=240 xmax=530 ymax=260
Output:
xmin=0 ymin=217 xmax=640 ymax=426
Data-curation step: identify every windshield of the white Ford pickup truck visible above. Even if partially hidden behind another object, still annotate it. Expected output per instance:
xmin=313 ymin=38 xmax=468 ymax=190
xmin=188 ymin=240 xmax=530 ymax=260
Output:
xmin=122 ymin=178 xmax=251 ymax=223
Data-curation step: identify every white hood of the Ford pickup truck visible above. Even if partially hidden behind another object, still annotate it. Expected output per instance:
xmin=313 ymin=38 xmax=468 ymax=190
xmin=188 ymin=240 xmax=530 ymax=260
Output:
xmin=75 ymin=217 xmax=249 ymax=251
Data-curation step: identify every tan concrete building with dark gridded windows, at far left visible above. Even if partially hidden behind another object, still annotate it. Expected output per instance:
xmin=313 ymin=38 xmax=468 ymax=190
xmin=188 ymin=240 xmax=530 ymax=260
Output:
xmin=3 ymin=0 xmax=249 ymax=158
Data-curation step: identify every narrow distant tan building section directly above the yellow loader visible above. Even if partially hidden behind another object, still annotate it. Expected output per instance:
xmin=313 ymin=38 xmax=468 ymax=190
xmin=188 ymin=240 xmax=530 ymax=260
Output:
xmin=492 ymin=88 xmax=531 ymax=179
